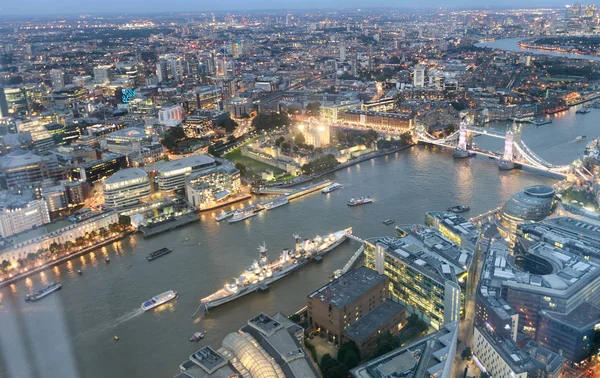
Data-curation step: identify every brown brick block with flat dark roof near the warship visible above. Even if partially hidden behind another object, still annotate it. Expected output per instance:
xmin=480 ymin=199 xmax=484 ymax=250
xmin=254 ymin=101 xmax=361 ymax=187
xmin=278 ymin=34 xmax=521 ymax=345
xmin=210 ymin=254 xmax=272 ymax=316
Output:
xmin=307 ymin=266 xmax=389 ymax=345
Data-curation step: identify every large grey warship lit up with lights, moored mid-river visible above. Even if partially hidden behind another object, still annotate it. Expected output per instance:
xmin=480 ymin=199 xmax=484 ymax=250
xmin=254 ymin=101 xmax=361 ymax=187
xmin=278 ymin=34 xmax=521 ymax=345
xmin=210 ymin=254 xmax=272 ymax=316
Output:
xmin=201 ymin=228 xmax=352 ymax=310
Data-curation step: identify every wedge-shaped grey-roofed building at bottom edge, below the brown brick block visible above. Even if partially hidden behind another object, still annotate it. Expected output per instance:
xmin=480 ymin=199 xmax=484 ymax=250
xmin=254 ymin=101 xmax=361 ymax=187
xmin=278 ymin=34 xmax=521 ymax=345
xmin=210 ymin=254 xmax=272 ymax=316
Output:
xmin=350 ymin=322 xmax=458 ymax=378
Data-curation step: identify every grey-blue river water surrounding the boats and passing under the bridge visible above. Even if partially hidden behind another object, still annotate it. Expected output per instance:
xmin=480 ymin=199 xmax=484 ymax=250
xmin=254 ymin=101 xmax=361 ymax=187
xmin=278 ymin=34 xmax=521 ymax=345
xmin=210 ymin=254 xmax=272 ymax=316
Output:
xmin=0 ymin=105 xmax=600 ymax=378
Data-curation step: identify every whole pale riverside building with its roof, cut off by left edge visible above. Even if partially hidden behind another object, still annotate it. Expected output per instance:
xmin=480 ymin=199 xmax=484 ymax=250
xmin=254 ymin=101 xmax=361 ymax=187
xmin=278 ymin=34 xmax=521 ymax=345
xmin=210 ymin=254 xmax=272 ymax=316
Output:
xmin=0 ymin=191 xmax=50 ymax=238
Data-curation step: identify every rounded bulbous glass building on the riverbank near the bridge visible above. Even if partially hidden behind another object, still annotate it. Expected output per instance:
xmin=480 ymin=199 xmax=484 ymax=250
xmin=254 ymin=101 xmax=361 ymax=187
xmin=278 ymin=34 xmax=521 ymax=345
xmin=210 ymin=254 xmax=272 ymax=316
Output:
xmin=498 ymin=185 xmax=554 ymax=243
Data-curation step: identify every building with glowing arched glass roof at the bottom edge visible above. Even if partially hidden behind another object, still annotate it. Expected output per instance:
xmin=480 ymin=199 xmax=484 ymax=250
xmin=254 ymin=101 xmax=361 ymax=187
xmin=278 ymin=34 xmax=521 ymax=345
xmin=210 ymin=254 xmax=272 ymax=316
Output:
xmin=175 ymin=313 xmax=320 ymax=378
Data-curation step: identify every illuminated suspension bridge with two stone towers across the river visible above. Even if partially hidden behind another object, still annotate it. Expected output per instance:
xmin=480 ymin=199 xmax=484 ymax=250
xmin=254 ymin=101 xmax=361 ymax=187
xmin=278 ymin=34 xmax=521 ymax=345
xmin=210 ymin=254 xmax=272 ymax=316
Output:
xmin=415 ymin=120 xmax=589 ymax=179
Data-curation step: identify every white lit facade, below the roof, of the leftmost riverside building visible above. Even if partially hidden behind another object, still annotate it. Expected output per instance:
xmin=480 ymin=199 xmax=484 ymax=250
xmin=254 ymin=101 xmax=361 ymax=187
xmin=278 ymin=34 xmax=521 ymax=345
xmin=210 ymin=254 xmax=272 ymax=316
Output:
xmin=0 ymin=199 xmax=50 ymax=238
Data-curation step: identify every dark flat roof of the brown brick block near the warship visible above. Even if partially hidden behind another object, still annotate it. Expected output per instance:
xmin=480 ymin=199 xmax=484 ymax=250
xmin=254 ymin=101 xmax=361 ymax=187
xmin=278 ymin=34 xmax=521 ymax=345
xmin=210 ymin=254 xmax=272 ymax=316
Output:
xmin=309 ymin=266 xmax=386 ymax=308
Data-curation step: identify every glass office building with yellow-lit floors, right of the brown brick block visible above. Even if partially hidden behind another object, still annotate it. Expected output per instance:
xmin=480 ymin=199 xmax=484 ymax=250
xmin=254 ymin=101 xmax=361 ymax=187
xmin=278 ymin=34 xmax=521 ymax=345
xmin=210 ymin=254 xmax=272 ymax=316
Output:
xmin=365 ymin=227 xmax=473 ymax=329
